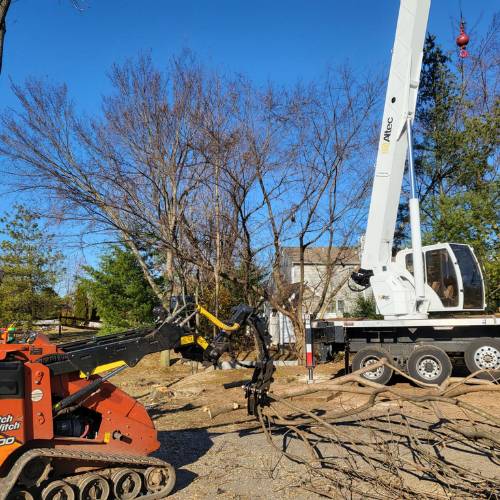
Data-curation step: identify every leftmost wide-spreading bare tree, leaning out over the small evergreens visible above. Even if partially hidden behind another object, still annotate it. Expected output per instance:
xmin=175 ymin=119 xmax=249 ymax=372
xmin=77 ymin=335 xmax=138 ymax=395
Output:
xmin=0 ymin=54 xmax=207 ymax=300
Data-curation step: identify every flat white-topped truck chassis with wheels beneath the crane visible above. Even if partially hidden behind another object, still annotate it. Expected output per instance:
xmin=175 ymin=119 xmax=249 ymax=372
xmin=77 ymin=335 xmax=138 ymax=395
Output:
xmin=312 ymin=316 xmax=500 ymax=383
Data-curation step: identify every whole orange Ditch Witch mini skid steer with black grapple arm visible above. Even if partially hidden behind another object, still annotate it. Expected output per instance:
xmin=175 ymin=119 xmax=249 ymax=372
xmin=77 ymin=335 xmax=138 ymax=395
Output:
xmin=0 ymin=305 xmax=273 ymax=500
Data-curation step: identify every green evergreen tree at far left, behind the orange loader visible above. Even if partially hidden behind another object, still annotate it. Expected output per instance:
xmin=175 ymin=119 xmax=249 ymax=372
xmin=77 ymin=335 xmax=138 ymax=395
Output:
xmin=0 ymin=205 xmax=62 ymax=328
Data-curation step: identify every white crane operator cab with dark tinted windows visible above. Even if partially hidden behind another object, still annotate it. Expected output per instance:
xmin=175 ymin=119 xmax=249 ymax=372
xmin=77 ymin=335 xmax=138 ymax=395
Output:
xmin=396 ymin=243 xmax=485 ymax=312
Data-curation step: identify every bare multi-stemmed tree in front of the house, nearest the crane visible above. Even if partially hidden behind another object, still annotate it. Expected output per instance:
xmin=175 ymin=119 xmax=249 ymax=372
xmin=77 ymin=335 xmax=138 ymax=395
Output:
xmin=234 ymin=68 xmax=378 ymax=360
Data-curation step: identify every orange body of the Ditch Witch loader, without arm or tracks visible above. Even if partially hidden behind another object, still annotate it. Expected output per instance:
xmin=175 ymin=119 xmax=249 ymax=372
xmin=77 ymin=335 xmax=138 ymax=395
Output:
xmin=0 ymin=335 xmax=159 ymax=476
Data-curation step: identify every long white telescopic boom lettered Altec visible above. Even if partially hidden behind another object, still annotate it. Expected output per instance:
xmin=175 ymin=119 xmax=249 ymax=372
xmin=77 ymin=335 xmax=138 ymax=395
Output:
xmin=361 ymin=0 xmax=430 ymax=272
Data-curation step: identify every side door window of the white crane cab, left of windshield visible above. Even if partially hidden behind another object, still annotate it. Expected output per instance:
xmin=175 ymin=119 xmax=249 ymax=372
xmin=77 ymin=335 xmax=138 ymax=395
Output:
xmin=425 ymin=248 xmax=459 ymax=307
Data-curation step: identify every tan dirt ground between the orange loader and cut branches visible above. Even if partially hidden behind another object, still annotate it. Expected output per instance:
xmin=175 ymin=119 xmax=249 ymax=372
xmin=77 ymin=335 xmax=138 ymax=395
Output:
xmin=114 ymin=355 xmax=500 ymax=499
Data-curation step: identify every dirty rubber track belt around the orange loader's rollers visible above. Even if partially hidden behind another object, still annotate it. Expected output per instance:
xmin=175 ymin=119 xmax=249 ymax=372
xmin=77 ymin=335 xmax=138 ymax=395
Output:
xmin=0 ymin=448 xmax=175 ymax=500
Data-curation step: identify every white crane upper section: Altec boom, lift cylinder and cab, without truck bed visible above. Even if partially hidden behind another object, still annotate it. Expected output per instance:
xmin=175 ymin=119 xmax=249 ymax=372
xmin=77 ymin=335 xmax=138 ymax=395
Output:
xmin=352 ymin=0 xmax=485 ymax=320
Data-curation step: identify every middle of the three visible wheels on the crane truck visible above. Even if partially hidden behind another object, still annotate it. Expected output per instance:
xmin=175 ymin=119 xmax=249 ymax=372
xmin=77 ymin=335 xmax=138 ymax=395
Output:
xmin=407 ymin=346 xmax=452 ymax=384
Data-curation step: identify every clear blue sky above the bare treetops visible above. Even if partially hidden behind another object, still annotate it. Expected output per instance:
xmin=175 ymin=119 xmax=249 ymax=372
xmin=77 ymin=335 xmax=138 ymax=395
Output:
xmin=0 ymin=0 xmax=500 ymax=280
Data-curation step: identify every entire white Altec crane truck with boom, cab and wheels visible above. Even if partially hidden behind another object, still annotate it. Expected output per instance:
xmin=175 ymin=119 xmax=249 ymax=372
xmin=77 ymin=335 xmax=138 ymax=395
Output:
xmin=312 ymin=0 xmax=500 ymax=384
